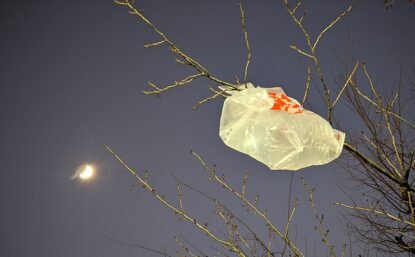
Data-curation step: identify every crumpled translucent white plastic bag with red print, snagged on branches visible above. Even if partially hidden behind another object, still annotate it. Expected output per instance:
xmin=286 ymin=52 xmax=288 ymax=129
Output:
xmin=219 ymin=83 xmax=345 ymax=170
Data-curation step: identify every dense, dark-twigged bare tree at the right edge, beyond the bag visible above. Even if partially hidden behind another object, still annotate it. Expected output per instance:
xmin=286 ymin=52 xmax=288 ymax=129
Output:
xmin=337 ymin=65 xmax=415 ymax=254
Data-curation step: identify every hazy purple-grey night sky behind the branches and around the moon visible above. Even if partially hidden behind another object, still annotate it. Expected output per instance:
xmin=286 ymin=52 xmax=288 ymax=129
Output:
xmin=0 ymin=0 xmax=415 ymax=257
